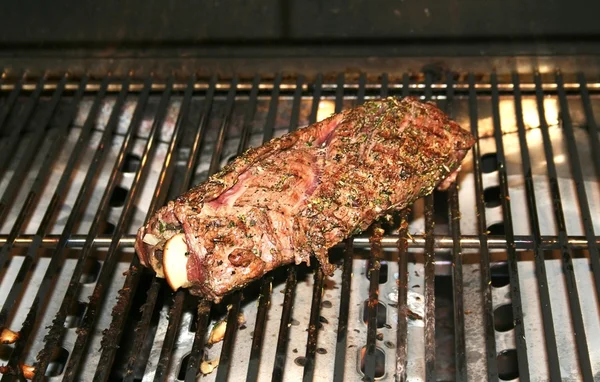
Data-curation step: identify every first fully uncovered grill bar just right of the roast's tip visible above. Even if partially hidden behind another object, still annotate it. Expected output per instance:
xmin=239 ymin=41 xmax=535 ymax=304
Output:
xmin=469 ymin=73 xmax=498 ymax=381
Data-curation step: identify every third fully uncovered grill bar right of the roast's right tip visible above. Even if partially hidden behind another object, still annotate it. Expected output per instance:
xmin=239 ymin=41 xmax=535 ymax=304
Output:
xmin=513 ymin=73 xmax=561 ymax=380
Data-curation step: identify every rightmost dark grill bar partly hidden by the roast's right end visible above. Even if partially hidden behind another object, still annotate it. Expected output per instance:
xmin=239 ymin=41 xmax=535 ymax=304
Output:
xmin=445 ymin=74 xmax=467 ymax=382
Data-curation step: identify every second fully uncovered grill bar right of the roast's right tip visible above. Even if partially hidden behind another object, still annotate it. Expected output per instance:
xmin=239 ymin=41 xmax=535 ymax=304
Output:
xmin=491 ymin=72 xmax=529 ymax=382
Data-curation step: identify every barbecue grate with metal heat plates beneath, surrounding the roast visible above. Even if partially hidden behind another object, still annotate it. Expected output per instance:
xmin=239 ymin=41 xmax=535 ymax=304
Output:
xmin=0 ymin=72 xmax=600 ymax=381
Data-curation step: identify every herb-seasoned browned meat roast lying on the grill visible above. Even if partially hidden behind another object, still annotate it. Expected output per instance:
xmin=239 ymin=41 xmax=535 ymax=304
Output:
xmin=135 ymin=97 xmax=474 ymax=301
